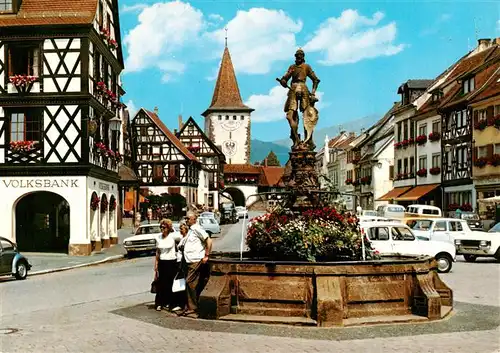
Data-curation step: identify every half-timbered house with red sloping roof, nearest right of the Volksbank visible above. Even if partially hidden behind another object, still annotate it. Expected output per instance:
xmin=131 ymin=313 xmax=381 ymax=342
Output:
xmin=131 ymin=108 xmax=201 ymax=205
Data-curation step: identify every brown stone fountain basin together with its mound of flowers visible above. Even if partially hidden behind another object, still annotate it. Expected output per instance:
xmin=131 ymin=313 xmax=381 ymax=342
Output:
xmin=199 ymin=207 xmax=453 ymax=326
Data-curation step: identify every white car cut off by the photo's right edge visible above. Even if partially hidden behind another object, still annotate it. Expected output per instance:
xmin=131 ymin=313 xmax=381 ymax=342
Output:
xmin=455 ymin=223 xmax=500 ymax=262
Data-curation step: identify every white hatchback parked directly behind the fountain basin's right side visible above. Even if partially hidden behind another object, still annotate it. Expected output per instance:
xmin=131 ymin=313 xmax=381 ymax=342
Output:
xmin=361 ymin=222 xmax=456 ymax=273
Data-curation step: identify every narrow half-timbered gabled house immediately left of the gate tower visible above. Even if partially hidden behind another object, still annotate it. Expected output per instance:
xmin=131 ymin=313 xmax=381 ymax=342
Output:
xmin=176 ymin=117 xmax=226 ymax=208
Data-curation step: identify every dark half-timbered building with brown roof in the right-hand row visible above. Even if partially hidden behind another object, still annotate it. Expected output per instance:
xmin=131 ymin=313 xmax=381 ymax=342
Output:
xmin=438 ymin=40 xmax=500 ymax=213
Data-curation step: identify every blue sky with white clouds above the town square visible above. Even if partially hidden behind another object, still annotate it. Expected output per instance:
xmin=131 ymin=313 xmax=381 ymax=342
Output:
xmin=119 ymin=0 xmax=500 ymax=141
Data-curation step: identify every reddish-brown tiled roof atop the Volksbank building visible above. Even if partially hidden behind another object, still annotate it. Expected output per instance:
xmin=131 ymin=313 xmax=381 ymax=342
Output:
xmin=0 ymin=0 xmax=97 ymax=27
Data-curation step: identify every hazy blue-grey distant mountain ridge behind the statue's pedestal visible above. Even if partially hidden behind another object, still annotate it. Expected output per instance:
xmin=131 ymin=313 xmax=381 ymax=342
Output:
xmin=272 ymin=114 xmax=380 ymax=148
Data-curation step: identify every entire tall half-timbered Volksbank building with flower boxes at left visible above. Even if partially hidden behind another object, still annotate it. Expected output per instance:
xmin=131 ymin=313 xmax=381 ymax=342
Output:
xmin=0 ymin=0 xmax=124 ymax=255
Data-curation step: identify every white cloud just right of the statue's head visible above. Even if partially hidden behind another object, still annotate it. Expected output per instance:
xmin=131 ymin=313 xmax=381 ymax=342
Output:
xmin=304 ymin=9 xmax=405 ymax=65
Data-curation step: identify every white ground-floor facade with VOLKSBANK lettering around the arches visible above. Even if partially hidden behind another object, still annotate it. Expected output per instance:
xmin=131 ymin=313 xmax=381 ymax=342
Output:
xmin=0 ymin=176 xmax=118 ymax=250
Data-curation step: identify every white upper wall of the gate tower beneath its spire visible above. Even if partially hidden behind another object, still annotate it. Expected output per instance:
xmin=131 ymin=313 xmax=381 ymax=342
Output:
xmin=205 ymin=110 xmax=250 ymax=164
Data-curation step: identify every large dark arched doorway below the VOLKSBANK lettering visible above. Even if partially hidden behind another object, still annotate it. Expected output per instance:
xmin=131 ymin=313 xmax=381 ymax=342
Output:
xmin=15 ymin=191 xmax=70 ymax=252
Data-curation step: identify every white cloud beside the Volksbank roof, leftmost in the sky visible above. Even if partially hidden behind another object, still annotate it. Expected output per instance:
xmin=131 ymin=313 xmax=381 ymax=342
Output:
xmin=124 ymin=1 xmax=205 ymax=80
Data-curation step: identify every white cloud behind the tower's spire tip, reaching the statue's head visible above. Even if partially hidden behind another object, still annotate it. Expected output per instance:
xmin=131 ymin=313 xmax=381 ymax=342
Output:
xmin=205 ymin=8 xmax=302 ymax=74
